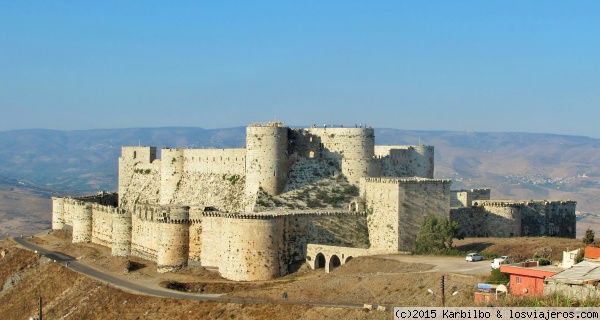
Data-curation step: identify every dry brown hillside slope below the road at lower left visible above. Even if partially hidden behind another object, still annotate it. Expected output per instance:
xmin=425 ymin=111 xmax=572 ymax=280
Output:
xmin=0 ymin=240 xmax=389 ymax=319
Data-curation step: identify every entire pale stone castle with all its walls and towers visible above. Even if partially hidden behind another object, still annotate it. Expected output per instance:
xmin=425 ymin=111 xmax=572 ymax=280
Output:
xmin=52 ymin=122 xmax=575 ymax=281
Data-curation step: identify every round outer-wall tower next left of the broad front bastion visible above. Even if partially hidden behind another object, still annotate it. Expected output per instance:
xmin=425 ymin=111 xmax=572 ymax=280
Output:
xmin=156 ymin=205 xmax=190 ymax=273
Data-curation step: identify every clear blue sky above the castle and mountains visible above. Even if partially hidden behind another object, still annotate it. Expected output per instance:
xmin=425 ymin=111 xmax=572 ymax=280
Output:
xmin=0 ymin=0 xmax=600 ymax=138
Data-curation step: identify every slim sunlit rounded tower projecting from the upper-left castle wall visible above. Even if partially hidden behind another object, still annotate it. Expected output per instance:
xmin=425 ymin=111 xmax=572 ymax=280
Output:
xmin=160 ymin=148 xmax=183 ymax=205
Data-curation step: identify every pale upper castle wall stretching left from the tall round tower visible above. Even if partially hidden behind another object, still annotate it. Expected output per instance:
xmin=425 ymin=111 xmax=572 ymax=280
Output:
xmin=119 ymin=147 xmax=245 ymax=211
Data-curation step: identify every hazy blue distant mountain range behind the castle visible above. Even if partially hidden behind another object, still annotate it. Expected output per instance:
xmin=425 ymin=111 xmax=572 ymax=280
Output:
xmin=0 ymin=127 xmax=600 ymax=213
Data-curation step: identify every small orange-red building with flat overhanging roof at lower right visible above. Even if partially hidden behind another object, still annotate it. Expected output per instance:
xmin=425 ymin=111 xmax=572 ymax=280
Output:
xmin=500 ymin=261 xmax=563 ymax=297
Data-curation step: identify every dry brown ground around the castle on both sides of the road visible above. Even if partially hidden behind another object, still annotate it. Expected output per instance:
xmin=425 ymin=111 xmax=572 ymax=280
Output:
xmin=0 ymin=231 xmax=592 ymax=319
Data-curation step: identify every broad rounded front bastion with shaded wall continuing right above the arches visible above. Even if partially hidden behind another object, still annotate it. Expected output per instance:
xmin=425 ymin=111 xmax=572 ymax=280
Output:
xmin=200 ymin=212 xmax=365 ymax=281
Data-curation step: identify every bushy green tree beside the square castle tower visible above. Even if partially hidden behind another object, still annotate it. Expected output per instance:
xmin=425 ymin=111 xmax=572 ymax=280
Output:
xmin=413 ymin=214 xmax=464 ymax=254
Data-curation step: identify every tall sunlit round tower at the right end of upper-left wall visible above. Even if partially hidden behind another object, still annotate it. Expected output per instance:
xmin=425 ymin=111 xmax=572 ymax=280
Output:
xmin=246 ymin=122 xmax=288 ymax=198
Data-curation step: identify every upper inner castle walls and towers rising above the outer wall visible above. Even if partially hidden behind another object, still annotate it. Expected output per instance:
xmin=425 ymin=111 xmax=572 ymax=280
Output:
xmin=119 ymin=122 xmax=434 ymax=212
